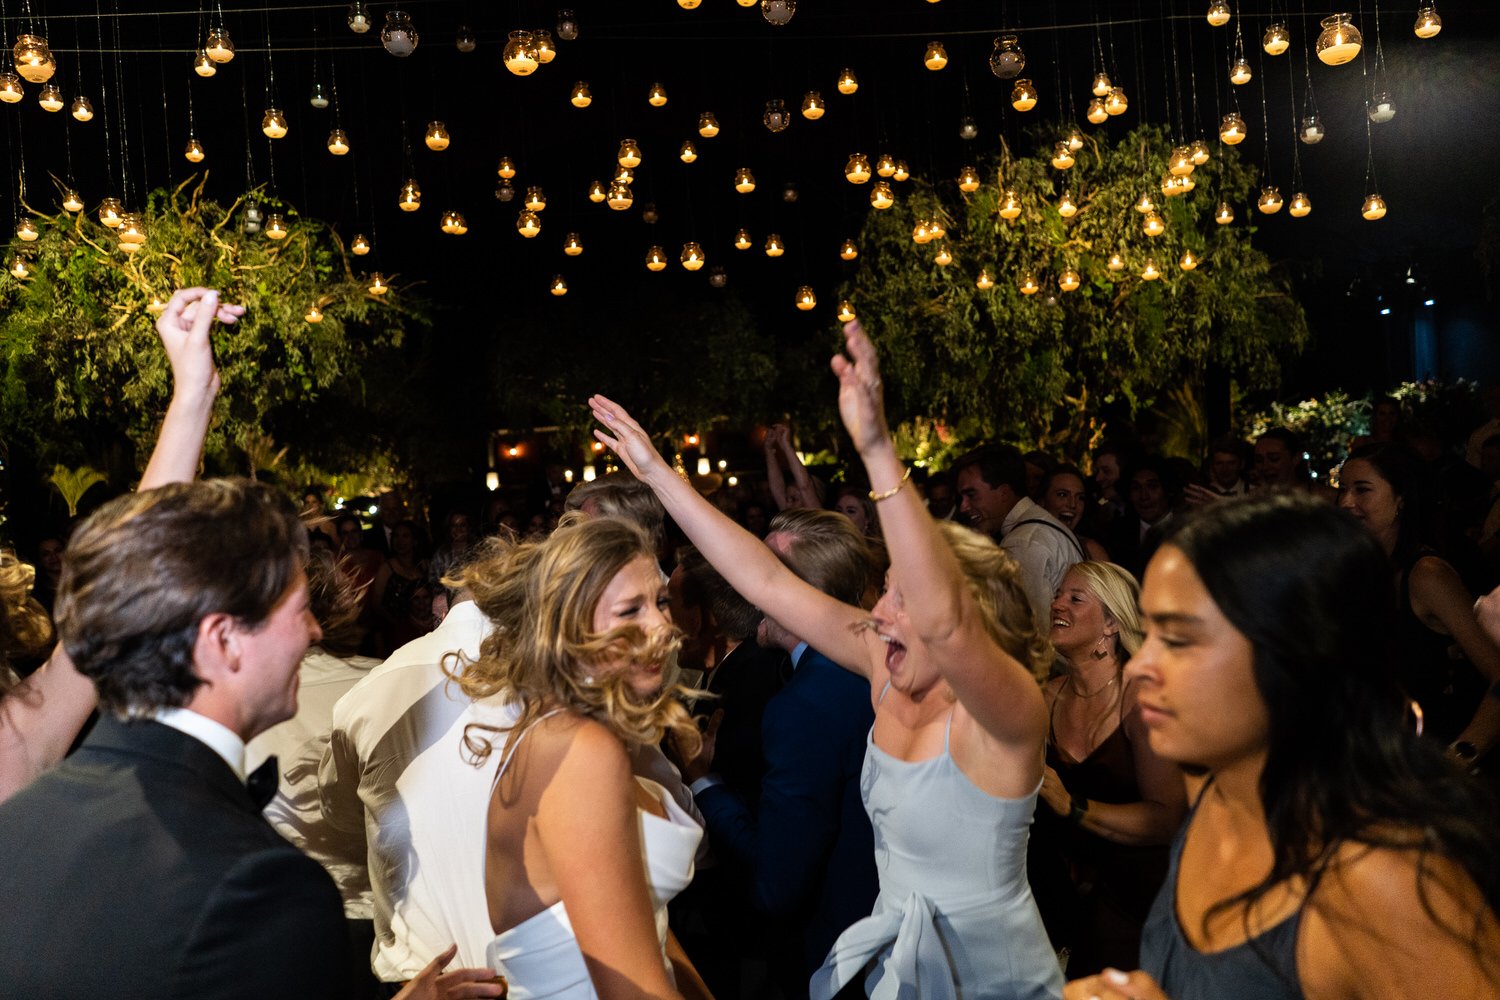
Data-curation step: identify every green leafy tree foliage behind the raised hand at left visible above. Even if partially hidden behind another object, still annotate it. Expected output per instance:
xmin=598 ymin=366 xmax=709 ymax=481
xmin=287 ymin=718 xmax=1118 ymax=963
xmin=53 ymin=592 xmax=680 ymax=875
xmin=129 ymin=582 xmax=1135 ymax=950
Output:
xmin=0 ymin=181 xmax=422 ymax=472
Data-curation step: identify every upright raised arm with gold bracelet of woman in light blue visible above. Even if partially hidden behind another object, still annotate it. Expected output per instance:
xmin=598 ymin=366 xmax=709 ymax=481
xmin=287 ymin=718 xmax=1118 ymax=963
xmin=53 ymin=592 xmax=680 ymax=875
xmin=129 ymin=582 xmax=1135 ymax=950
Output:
xmin=833 ymin=322 xmax=1046 ymax=745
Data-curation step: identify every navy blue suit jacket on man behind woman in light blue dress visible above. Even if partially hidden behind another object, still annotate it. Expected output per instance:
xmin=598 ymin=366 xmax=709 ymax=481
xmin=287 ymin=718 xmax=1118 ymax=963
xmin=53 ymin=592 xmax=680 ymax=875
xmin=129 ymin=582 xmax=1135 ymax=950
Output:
xmin=698 ymin=649 xmax=879 ymax=973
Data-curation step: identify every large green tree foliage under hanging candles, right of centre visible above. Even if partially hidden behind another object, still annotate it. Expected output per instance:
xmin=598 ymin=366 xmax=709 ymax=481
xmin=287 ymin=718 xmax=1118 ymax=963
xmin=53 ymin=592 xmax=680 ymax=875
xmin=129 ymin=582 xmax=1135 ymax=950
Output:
xmin=843 ymin=126 xmax=1308 ymax=464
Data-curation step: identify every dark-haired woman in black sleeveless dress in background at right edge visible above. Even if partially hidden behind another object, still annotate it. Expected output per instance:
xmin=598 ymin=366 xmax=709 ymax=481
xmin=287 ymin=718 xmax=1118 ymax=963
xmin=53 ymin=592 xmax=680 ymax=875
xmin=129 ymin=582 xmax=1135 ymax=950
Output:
xmin=1338 ymin=444 xmax=1500 ymax=760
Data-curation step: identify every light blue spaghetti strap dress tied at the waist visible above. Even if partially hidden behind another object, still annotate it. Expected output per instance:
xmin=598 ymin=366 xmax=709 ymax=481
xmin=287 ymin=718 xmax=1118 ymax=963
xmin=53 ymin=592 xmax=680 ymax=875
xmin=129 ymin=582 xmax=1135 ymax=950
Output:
xmin=810 ymin=707 xmax=1062 ymax=1000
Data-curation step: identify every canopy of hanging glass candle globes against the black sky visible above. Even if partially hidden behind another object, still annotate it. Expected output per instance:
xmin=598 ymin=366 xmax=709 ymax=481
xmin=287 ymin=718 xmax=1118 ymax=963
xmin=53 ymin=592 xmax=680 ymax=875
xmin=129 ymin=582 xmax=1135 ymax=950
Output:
xmin=0 ymin=0 xmax=1497 ymax=309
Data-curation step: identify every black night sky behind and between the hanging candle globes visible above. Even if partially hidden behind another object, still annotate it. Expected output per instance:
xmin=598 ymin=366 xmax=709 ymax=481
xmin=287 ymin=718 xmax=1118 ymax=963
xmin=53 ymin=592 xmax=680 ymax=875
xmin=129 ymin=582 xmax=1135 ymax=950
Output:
xmin=0 ymin=0 xmax=1500 ymax=401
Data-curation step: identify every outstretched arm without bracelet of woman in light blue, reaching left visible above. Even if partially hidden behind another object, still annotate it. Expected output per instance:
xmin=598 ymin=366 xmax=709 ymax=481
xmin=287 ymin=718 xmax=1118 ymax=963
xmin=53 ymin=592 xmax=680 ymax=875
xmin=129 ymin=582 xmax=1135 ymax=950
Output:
xmin=588 ymin=396 xmax=870 ymax=676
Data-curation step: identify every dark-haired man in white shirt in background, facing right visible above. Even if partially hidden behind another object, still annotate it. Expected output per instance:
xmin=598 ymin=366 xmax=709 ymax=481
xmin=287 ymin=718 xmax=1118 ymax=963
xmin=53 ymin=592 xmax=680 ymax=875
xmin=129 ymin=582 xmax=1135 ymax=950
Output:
xmin=954 ymin=444 xmax=1088 ymax=628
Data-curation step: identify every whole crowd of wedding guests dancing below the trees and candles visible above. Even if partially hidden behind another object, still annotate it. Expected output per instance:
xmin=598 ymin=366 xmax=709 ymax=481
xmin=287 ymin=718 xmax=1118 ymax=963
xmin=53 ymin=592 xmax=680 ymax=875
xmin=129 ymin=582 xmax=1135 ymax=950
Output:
xmin=0 ymin=289 xmax=1500 ymax=1000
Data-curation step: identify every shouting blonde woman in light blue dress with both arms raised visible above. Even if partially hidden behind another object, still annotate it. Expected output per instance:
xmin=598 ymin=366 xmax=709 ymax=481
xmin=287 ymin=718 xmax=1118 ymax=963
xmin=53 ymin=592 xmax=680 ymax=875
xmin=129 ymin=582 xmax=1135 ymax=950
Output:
xmin=590 ymin=322 xmax=1062 ymax=1000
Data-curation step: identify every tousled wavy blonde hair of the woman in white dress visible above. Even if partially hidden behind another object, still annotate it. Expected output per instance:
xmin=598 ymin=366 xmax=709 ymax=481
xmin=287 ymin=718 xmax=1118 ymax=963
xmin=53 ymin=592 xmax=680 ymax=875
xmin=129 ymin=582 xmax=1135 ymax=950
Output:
xmin=444 ymin=514 xmax=701 ymax=765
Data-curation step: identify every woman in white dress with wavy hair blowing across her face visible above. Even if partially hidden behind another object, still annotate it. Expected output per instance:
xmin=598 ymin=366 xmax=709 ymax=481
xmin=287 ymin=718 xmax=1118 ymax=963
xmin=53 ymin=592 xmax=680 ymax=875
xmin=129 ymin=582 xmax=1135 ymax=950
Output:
xmin=458 ymin=519 xmax=708 ymax=1000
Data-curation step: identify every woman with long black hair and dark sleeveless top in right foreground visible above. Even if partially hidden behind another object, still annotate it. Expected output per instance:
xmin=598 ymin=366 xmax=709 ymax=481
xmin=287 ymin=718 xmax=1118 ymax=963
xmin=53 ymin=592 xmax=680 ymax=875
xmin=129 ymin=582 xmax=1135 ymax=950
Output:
xmin=1065 ymin=495 xmax=1500 ymax=1000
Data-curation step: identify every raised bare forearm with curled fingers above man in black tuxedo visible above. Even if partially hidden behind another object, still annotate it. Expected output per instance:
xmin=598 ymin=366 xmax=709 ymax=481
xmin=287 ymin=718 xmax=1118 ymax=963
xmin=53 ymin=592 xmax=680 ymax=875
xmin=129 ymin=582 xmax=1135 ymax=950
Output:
xmin=141 ymin=288 xmax=245 ymax=490
